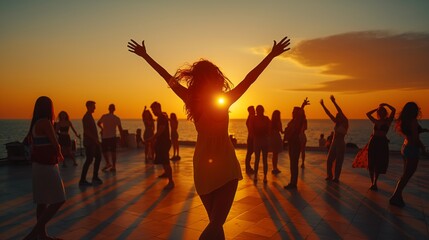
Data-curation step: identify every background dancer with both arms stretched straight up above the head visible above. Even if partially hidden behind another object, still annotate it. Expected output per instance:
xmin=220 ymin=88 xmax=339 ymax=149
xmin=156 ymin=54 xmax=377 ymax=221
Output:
xmin=320 ymin=95 xmax=349 ymax=183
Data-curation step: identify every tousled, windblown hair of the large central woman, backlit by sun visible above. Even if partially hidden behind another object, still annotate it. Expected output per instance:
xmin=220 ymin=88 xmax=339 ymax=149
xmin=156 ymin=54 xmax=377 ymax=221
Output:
xmin=174 ymin=59 xmax=232 ymax=121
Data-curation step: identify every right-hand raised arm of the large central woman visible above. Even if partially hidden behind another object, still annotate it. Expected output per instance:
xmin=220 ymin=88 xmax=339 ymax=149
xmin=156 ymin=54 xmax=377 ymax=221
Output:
xmin=229 ymin=37 xmax=290 ymax=103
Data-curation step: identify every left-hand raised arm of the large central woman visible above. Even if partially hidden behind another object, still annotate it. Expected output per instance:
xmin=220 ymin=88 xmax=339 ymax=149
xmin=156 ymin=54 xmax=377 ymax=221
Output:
xmin=127 ymin=39 xmax=187 ymax=100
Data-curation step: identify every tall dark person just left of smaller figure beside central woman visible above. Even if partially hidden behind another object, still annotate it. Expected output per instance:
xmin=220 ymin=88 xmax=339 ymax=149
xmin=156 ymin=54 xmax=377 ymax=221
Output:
xmin=148 ymin=102 xmax=174 ymax=190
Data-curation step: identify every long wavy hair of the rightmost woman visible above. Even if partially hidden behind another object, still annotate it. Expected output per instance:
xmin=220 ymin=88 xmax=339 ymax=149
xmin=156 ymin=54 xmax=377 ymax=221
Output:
xmin=395 ymin=102 xmax=421 ymax=136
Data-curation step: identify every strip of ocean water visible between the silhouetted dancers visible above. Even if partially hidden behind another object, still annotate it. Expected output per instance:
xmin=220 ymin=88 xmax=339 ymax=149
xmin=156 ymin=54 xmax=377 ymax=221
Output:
xmin=0 ymin=119 xmax=429 ymax=158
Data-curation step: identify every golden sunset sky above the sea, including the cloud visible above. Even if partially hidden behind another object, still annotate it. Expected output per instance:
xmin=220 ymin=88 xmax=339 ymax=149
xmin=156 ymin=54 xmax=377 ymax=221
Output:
xmin=0 ymin=0 xmax=429 ymax=119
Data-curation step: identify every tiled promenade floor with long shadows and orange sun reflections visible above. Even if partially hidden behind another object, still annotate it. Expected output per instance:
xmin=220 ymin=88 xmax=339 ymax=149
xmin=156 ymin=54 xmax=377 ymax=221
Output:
xmin=0 ymin=147 xmax=429 ymax=240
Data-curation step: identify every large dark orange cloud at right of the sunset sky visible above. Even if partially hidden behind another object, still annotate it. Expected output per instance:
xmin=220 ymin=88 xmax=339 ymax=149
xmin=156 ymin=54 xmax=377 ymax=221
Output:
xmin=288 ymin=31 xmax=429 ymax=92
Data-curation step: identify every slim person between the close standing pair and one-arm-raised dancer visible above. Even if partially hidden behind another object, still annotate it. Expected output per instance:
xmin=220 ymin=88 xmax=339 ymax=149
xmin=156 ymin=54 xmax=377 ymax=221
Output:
xmin=269 ymin=110 xmax=283 ymax=174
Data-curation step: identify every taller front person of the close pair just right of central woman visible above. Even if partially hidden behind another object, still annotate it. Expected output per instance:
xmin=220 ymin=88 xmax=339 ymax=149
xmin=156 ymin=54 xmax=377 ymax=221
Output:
xmin=252 ymin=105 xmax=271 ymax=183
